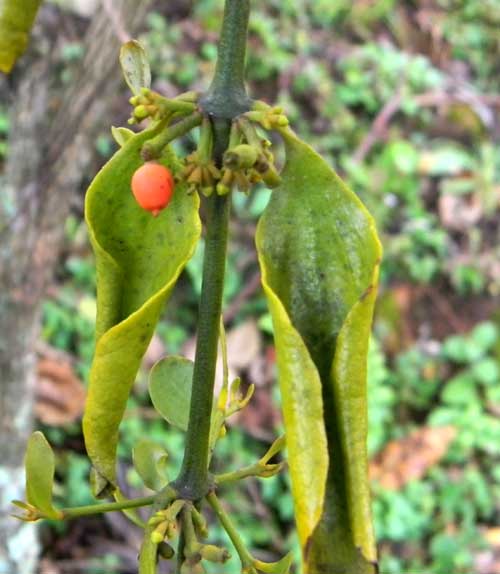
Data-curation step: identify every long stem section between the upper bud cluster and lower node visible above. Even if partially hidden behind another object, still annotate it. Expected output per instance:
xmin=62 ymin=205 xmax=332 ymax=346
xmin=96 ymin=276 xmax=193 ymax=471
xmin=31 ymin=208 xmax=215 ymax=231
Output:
xmin=175 ymin=195 xmax=230 ymax=500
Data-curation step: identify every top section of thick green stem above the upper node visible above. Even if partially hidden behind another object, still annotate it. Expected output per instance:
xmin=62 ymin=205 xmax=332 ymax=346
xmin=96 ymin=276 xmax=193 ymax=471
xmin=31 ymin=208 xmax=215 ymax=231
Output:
xmin=200 ymin=0 xmax=251 ymax=119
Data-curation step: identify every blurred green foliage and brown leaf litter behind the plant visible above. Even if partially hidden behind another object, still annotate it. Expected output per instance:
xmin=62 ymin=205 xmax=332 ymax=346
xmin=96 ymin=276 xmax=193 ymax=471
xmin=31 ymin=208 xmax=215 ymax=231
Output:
xmin=0 ymin=0 xmax=500 ymax=574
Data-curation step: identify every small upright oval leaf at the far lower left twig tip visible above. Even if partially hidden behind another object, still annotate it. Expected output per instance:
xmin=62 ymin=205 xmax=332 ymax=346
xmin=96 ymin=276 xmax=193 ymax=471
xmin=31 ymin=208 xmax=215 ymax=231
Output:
xmin=25 ymin=431 xmax=60 ymax=518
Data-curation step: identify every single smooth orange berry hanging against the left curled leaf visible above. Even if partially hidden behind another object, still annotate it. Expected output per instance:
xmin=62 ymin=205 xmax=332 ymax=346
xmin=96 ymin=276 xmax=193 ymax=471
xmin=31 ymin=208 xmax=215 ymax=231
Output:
xmin=131 ymin=162 xmax=175 ymax=217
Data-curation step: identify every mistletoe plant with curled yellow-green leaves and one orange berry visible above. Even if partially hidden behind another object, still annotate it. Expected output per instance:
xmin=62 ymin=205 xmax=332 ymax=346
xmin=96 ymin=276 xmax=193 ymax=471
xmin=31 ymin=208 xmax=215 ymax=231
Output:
xmin=16 ymin=0 xmax=381 ymax=574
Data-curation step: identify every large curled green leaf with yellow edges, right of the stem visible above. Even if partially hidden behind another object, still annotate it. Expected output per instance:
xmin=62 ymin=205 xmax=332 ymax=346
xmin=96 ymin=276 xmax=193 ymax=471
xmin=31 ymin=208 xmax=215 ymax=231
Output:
xmin=257 ymin=130 xmax=381 ymax=574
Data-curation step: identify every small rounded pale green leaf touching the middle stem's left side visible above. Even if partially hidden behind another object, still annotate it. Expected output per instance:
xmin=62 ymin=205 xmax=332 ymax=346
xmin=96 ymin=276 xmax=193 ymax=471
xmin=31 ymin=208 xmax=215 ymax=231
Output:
xmin=149 ymin=355 xmax=194 ymax=431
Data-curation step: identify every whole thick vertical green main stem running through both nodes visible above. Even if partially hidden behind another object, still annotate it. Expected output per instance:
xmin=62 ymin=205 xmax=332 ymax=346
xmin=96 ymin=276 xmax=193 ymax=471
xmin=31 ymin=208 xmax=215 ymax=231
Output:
xmin=175 ymin=0 xmax=250 ymax=501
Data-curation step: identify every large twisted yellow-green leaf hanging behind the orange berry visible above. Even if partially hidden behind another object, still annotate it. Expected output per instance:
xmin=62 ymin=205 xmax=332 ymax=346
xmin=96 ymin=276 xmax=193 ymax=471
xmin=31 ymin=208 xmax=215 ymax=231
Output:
xmin=83 ymin=125 xmax=201 ymax=494
